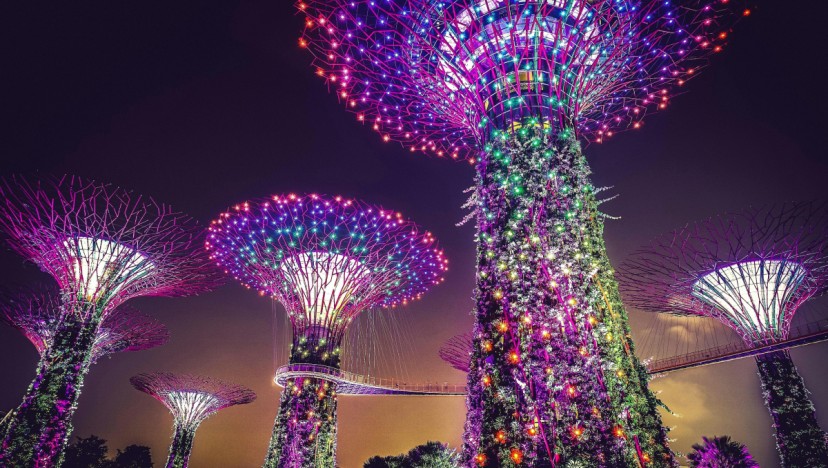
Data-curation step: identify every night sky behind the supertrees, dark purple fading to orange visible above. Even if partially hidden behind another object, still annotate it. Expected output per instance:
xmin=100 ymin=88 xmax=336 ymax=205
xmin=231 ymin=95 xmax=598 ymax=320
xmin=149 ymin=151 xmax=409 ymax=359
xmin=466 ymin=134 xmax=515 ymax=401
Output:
xmin=0 ymin=1 xmax=828 ymax=468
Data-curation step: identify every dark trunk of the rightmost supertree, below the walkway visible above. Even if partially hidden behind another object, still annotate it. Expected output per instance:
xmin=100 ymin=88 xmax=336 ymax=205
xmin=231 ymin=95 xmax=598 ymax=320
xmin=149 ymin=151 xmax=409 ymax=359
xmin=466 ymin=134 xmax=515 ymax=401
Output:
xmin=756 ymin=351 xmax=828 ymax=468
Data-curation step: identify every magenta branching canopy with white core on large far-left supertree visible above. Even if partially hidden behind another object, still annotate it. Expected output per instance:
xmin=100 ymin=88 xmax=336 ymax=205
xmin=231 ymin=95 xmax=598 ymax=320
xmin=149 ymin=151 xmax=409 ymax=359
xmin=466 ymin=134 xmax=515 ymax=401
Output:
xmin=0 ymin=175 xmax=221 ymax=315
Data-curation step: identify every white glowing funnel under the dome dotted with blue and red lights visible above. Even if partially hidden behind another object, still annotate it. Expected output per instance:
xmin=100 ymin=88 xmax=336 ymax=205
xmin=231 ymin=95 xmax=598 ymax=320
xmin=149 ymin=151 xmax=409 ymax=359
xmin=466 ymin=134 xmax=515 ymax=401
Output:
xmin=280 ymin=252 xmax=371 ymax=327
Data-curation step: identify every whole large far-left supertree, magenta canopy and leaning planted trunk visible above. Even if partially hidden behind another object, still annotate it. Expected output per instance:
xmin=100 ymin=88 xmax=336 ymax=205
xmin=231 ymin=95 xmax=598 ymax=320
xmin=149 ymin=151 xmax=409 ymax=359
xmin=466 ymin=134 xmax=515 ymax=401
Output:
xmin=0 ymin=176 xmax=218 ymax=467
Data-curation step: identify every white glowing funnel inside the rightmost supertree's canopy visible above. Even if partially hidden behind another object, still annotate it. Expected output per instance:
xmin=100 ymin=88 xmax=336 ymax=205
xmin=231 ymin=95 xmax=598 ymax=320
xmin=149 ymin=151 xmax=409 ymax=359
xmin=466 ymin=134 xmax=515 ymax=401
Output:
xmin=693 ymin=260 xmax=806 ymax=337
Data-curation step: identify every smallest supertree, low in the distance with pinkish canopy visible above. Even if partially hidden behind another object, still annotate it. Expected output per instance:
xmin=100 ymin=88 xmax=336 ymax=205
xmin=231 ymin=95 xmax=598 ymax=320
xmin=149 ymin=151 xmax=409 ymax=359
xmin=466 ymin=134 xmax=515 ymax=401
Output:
xmin=129 ymin=372 xmax=256 ymax=468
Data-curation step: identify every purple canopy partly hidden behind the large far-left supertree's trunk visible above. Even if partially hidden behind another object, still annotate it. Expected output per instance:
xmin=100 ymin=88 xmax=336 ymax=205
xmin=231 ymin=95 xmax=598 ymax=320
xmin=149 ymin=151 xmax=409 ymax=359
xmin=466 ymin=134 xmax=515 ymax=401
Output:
xmin=0 ymin=288 xmax=170 ymax=365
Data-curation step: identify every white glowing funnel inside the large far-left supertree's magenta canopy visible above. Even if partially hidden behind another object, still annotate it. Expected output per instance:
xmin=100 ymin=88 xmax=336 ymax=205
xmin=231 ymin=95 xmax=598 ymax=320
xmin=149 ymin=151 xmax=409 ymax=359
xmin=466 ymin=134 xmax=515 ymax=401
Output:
xmin=63 ymin=237 xmax=153 ymax=302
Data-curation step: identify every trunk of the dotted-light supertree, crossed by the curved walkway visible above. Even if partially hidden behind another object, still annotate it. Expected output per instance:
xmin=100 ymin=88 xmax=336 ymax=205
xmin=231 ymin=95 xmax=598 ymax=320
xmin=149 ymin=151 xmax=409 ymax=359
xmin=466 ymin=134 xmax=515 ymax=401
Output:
xmin=264 ymin=330 xmax=340 ymax=468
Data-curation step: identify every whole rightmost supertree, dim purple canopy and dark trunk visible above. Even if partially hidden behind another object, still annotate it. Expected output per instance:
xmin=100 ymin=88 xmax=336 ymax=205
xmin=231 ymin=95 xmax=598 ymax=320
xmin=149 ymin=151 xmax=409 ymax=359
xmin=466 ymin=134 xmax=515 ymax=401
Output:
xmin=621 ymin=202 xmax=828 ymax=467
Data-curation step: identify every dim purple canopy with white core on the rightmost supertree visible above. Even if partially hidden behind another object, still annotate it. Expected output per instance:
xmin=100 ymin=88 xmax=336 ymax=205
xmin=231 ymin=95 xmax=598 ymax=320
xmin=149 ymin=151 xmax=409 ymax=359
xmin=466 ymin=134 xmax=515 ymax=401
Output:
xmin=619 ymin=202 xmax=828 ymax=344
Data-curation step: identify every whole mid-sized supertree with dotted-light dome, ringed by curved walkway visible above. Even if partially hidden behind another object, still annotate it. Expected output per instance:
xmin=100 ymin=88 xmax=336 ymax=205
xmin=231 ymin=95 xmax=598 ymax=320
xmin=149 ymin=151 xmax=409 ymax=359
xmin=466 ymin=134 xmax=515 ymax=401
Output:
xmin=206 ymin=194 xmax=447 ymax=468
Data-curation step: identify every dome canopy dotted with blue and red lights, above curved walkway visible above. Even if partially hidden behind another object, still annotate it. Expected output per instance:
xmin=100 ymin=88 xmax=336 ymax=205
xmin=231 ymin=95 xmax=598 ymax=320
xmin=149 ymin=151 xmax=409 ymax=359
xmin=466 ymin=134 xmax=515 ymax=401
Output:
xmin=206 ymin=194 xmax=448 ymax=321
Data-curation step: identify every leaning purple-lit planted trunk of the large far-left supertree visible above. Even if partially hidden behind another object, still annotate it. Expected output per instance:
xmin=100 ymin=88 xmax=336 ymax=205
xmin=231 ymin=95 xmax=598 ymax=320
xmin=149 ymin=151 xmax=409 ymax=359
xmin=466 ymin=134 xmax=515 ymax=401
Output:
xmin=0 ymin=315 xmax=98 ymax=467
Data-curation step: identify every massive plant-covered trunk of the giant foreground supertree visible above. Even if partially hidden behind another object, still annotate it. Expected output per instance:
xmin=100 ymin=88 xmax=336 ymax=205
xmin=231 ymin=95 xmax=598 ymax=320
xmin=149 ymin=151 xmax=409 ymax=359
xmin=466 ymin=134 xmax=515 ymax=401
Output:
xmin=464 ymin=121 xmax=674 ymax=467
